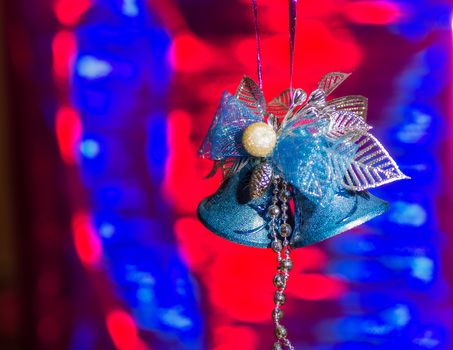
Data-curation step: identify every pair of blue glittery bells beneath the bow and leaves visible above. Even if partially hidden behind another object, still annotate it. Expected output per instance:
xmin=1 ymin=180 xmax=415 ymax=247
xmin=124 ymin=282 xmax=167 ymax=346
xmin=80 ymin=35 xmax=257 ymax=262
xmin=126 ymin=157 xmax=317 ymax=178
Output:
xmin=198 ymin=163 xmax=388 ymax=248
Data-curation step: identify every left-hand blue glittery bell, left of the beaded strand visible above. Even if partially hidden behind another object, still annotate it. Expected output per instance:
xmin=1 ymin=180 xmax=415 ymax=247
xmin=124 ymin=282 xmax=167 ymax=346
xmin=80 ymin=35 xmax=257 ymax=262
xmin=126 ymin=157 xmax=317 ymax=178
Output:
xmin=198 ymin=162 xmax=272 ymax=248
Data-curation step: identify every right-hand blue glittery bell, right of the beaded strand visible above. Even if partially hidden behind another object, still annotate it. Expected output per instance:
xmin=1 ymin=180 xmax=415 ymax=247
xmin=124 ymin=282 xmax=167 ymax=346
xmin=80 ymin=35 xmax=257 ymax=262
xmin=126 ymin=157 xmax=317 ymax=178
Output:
xmin=290 ymin=190 xmax=388 ymax=248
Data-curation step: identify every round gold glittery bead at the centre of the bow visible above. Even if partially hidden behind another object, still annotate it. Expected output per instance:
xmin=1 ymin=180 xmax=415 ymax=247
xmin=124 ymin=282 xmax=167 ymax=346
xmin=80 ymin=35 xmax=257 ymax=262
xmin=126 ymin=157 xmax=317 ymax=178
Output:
xmin=242 ymin=122 xmax=277 ymax=157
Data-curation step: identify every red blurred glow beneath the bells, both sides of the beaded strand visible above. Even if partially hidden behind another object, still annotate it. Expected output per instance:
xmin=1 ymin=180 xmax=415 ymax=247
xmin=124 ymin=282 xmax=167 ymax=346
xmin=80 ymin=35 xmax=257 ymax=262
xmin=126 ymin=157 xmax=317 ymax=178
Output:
xmin=175 ymin=217 xmax=345 ymax=322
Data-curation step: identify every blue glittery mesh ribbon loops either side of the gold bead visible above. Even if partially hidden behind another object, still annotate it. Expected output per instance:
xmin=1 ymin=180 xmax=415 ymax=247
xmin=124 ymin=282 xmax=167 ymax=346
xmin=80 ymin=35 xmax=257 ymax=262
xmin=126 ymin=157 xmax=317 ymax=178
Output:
xmin=199 ymin=87 xmax=355 ymax=201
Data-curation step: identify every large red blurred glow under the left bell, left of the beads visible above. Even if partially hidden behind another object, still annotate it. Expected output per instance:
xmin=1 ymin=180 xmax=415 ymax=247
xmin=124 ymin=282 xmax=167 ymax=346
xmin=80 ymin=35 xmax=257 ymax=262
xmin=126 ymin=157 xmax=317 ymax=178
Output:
xmin=175 ymin=218 xmax=276 ymax=322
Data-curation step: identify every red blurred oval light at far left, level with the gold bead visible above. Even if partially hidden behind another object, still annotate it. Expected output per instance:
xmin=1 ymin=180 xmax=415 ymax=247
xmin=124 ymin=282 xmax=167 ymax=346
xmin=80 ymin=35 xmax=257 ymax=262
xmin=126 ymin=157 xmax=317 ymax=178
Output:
xmin=55 ymin=106 xmax=82 ymax=164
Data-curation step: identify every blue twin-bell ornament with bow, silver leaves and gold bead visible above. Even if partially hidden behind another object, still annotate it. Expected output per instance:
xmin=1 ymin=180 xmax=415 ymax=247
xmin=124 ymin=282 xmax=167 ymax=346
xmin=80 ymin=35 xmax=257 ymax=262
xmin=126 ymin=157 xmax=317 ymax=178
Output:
xmin=198 ymin=72 xmax=407 ymax=251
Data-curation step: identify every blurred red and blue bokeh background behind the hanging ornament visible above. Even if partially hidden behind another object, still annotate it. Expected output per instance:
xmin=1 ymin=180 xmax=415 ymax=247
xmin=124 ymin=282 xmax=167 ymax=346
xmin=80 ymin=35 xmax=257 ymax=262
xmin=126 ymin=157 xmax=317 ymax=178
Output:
xmin=0 ymin=0 xmax=453 ymax=350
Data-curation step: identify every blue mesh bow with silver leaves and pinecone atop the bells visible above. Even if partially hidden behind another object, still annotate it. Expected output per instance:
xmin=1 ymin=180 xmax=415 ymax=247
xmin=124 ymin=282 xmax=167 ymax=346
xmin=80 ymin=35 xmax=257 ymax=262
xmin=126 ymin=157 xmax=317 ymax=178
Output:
xmin=198 ymin=72 xmax=408 ymax=204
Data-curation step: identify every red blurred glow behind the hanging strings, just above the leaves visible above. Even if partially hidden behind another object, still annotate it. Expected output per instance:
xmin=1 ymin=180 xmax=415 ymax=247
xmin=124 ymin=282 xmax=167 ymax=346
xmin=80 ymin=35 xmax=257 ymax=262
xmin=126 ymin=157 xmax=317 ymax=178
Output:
xmin=233 ymin=25 xmax=362 ymax=100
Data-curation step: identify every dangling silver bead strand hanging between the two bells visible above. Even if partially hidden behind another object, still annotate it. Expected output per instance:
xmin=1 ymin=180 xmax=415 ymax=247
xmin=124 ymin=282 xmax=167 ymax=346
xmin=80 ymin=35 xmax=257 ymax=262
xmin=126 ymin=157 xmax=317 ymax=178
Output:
xmin=268 ymin=176 xmax=294 ymax=350
